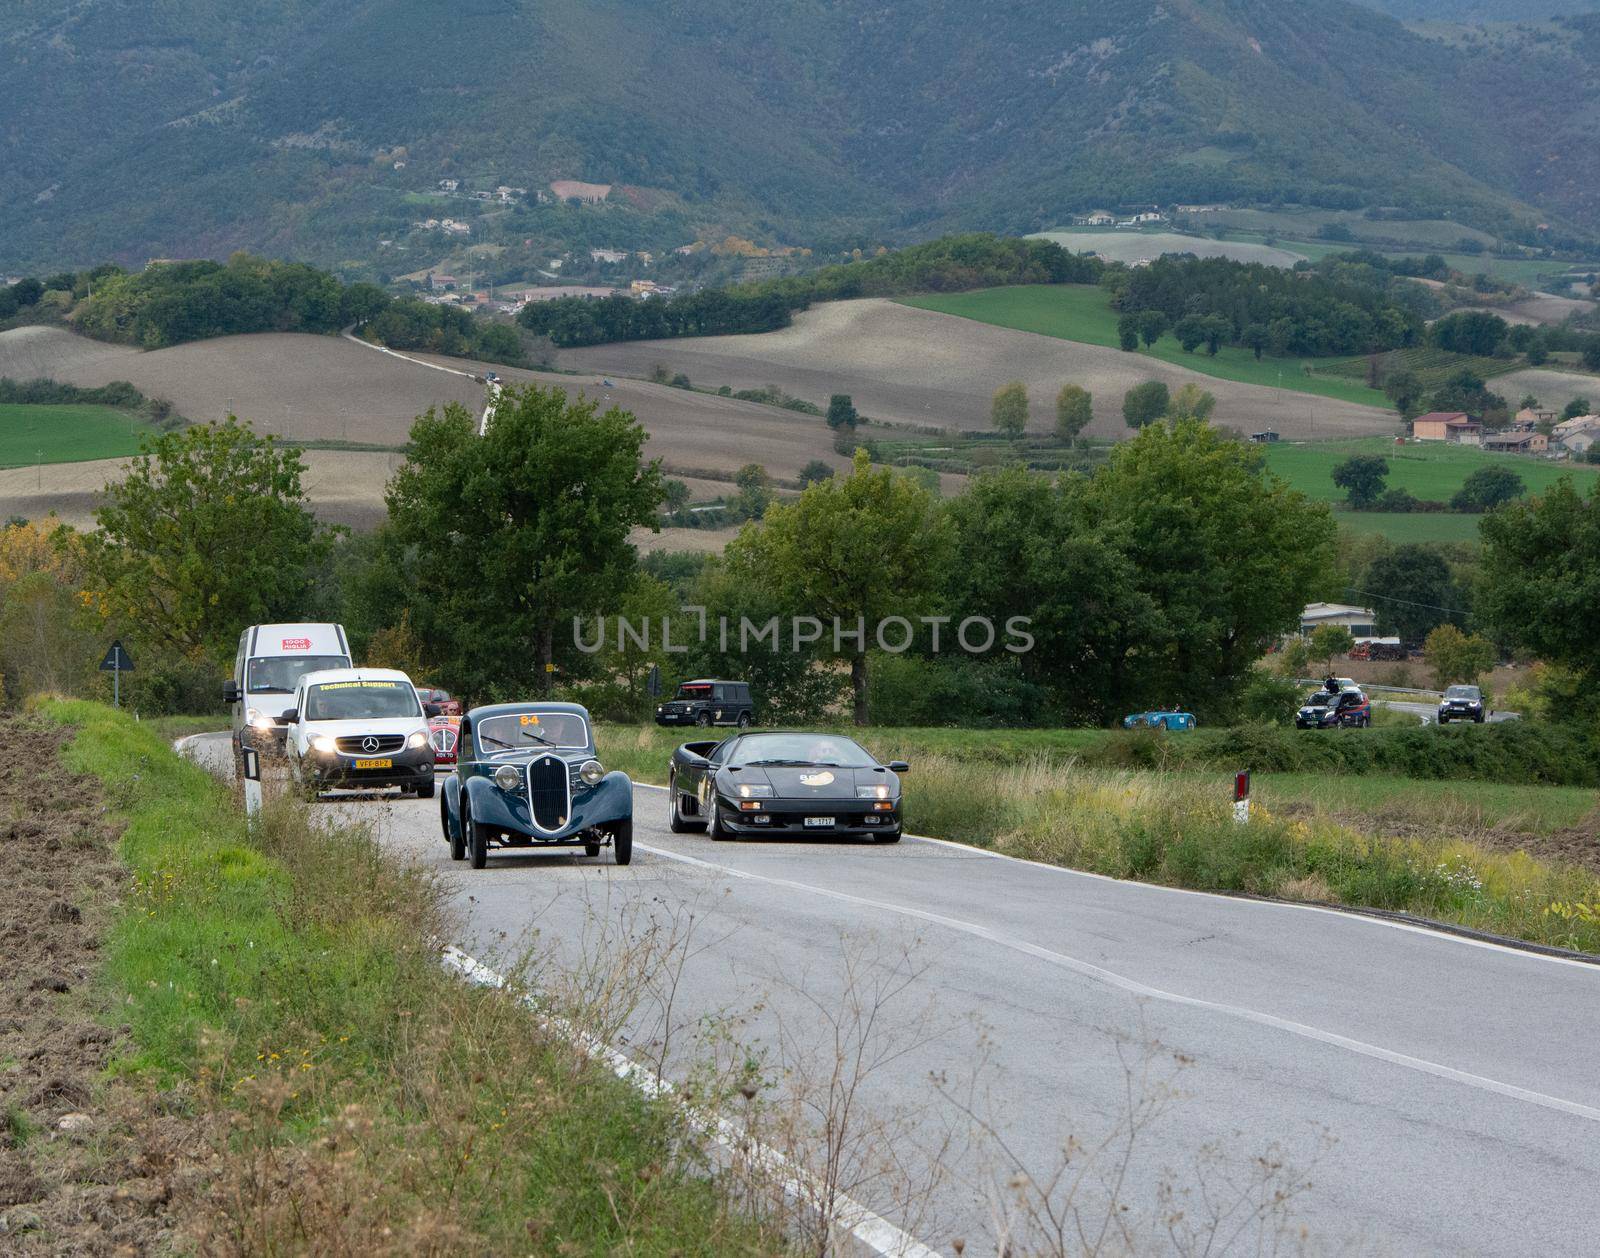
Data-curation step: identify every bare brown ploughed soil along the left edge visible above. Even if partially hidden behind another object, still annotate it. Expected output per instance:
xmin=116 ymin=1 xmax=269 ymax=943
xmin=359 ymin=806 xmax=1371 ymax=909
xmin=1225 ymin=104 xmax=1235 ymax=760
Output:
xmin=0 ymin=719 xmax=202 ymax=1255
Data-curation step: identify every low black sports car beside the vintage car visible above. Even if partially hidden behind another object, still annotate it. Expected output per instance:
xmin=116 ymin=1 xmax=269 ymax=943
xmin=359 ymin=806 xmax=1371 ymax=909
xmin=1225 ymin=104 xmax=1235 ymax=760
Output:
xmin=667 ymin=731 xmax=910 ymax=843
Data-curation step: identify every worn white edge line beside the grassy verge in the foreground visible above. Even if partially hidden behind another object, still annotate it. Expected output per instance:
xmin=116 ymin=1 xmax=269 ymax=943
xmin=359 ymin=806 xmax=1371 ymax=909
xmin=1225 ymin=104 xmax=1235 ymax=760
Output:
xmin=443 ymin=946 xmax=942 ymax=1258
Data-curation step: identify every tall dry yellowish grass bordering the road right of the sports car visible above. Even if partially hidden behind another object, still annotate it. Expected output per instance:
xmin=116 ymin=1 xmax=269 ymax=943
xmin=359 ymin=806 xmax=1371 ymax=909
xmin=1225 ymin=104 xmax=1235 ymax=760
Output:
xmin=907 ymin=757 xmax=1600 ymax=952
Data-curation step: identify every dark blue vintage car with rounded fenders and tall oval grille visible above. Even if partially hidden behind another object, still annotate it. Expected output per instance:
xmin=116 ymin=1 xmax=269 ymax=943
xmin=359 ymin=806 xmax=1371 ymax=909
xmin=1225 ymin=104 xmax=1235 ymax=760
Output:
xmin=440 ymin=703 xmax=634 ymax=869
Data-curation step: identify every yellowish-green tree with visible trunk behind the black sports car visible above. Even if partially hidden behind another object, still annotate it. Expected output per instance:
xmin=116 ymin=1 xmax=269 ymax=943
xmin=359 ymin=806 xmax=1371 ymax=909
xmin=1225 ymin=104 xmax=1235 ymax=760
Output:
xmin=728 ymin=453 xmax=949 ymax=725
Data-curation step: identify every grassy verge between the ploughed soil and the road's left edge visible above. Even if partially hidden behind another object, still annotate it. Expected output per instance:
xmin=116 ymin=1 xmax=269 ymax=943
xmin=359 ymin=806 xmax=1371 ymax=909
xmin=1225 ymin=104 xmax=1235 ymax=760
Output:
xmin=56 ymin=703 xmax=776 ymax=1253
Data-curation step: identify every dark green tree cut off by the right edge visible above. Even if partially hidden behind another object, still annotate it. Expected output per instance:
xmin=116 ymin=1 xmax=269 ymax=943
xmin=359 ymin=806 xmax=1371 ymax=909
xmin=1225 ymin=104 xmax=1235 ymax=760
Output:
xmin=1475 ymin=480 xmax=1600 ymax=693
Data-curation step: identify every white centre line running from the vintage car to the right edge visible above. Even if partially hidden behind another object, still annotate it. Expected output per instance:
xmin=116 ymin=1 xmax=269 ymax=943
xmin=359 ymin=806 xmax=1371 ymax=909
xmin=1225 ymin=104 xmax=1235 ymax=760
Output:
xmin=635 ymin=825 xmax=1600 ymax=1122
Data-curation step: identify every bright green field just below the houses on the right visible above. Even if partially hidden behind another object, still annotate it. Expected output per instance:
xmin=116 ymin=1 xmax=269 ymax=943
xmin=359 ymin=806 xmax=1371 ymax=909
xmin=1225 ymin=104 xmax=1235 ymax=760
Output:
xmin=1266 ymin=437 xmax=1600 ymax=505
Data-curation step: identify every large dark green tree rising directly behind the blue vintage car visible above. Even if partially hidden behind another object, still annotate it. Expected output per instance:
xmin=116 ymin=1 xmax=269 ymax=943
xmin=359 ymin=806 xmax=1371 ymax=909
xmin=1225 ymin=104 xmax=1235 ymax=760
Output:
xmin=386 ymin=386 xmax=664 ymax=695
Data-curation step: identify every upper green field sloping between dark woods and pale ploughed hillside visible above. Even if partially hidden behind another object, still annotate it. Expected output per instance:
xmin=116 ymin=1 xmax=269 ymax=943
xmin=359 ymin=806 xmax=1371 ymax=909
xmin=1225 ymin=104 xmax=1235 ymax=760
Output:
xmin=901 ymin=283 xmax=1389 ymax=410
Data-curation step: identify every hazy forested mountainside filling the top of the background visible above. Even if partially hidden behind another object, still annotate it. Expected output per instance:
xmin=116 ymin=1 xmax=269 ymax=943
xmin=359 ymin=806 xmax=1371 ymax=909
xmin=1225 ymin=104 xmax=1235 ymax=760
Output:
xmin=0 ymin=0 xmax=1600 ymax=274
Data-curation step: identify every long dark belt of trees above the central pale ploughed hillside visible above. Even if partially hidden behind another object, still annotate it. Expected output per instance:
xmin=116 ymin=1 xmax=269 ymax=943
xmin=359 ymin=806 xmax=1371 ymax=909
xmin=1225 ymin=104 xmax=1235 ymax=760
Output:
xmin=518 ymin=234 xmax=1104 ymax=347
